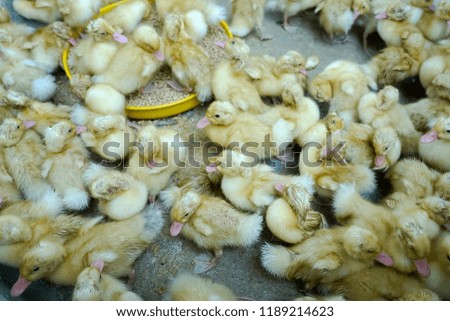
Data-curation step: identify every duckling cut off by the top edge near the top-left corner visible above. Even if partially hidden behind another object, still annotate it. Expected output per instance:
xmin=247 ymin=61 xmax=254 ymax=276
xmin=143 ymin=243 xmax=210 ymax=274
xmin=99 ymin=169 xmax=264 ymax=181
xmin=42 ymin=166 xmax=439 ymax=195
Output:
xmin=12 ymin=0 xmax=62 ymax=23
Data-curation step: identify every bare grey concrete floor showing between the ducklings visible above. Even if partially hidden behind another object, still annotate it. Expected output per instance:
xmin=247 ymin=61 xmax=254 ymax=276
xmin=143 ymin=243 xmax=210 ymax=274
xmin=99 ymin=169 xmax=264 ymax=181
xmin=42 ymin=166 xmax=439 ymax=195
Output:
xmin=0 ymin=0 xmax=422 ymax=301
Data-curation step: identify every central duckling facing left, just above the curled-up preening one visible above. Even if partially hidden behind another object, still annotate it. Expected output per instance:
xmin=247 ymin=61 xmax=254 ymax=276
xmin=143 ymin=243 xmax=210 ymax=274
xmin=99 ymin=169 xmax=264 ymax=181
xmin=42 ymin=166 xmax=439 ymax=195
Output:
xmin=210 ymin=150 xmax=314 ymax=211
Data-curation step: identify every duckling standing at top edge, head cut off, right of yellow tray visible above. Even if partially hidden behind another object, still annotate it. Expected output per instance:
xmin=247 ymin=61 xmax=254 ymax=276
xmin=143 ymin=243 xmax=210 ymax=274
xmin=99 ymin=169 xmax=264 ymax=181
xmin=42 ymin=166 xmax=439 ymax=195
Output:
xmin=230 ymin=0 xmax=273 ymax=40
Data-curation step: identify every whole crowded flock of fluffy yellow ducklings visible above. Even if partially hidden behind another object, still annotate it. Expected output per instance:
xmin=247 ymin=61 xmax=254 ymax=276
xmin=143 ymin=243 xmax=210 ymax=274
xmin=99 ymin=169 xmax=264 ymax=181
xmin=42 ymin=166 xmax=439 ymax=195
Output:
xmin=0 ymin=0 xmax=450 ymax=300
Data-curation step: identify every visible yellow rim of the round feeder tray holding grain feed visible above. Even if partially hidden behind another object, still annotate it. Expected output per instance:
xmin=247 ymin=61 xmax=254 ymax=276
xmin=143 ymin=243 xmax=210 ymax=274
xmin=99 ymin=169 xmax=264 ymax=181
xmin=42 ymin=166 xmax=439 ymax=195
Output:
xmin=61 ymin=0 xmax=233 ymax=119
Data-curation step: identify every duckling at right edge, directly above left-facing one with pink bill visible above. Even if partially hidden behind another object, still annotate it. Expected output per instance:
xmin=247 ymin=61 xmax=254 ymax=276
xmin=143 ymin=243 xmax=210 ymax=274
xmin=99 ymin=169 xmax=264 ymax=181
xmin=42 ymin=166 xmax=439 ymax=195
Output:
xmin=404 ymin=98 xmax=450 ymax=133
